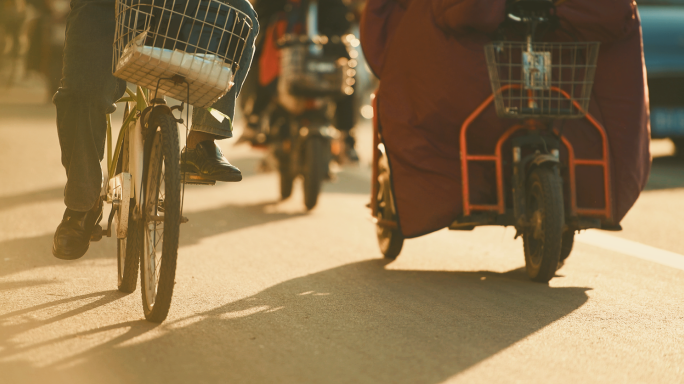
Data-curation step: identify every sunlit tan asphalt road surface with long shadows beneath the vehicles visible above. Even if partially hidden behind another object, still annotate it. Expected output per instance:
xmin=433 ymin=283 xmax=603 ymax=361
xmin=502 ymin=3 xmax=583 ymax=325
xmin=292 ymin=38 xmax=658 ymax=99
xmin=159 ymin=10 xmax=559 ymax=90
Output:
xmin=0 ymin=85 xmax=684 ymax=384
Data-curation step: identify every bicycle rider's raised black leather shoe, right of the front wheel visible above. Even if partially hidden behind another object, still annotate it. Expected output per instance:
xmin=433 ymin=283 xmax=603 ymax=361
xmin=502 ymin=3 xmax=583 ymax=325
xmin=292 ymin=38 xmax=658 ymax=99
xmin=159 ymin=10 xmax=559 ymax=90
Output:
xmin=181 ymin=140 xmax=242 ymax=181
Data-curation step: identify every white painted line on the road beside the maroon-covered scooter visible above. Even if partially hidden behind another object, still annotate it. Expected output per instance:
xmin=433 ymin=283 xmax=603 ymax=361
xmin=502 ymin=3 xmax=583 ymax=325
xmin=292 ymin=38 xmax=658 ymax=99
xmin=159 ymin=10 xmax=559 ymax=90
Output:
xmin=575 ymin=230 xmax=684 ymax=271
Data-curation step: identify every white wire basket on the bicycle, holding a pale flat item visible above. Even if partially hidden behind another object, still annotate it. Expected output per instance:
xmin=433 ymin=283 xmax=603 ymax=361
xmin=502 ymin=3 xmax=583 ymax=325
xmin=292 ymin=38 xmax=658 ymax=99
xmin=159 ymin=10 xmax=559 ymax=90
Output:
xmin=113 ymin=0 xmax=252 ymax=107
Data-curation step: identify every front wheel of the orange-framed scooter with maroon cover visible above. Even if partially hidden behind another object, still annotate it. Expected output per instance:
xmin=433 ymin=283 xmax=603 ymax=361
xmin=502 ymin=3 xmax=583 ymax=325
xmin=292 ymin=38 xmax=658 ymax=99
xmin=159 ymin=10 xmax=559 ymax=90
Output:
xmin=523 ymin=166 xmax=565 ymax=283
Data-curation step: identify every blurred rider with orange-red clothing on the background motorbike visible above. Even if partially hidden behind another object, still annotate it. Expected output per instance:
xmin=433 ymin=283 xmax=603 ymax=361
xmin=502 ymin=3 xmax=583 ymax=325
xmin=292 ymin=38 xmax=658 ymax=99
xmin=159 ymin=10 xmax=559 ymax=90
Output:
xmin=240 ymin=0 xmax=358 ymax=161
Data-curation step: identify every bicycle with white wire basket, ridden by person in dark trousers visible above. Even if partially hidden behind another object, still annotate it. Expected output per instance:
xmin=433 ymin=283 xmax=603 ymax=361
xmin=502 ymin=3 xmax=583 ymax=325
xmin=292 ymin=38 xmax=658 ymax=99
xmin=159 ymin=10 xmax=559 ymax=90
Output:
xmin=93 ymin=0 xmax=252 ymax=322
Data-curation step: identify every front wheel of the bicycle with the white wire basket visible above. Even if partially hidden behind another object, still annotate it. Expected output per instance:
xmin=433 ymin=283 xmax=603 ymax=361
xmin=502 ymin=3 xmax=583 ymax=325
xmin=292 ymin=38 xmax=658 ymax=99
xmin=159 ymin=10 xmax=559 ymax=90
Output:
xmin=140 ymin=114 xmax=181 ymax=323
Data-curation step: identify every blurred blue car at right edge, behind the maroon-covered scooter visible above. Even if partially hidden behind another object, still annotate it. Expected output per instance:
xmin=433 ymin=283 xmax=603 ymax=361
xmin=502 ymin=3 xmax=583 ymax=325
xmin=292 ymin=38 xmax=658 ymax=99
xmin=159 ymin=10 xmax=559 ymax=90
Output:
xmin=637 ymin=0 xmax=684 ymax=157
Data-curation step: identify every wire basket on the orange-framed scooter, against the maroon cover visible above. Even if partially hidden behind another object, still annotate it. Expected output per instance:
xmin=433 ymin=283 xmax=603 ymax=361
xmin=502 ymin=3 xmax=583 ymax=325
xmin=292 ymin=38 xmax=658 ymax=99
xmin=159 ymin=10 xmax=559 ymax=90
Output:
xmin=485 ymin=41 xmax=600 ymax=119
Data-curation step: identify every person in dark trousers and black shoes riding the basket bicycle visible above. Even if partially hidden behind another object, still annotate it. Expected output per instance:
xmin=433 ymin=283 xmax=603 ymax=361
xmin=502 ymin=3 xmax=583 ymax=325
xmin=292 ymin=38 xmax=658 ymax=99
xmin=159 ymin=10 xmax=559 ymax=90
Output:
xmin=52 ymin=0 xmax=259 ymax=260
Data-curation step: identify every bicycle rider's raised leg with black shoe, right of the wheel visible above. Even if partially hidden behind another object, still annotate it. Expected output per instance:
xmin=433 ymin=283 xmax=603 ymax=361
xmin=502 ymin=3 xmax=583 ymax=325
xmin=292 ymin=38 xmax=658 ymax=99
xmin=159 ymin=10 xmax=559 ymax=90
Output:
xmin=183 ymin=0 xmax=259 ymax=181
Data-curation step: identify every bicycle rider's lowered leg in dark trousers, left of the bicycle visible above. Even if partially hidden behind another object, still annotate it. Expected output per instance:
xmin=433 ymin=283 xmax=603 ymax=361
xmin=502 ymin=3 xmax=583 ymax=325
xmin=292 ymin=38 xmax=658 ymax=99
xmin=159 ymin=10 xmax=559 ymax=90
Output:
xmin=53 ymin=0 xmax=126 ymax=259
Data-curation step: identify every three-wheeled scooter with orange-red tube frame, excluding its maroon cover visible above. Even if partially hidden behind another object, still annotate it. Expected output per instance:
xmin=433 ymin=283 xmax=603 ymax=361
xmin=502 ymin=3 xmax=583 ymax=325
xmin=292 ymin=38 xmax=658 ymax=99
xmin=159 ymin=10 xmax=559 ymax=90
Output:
xmin=370 ymin=0 xmax=613 ymax=283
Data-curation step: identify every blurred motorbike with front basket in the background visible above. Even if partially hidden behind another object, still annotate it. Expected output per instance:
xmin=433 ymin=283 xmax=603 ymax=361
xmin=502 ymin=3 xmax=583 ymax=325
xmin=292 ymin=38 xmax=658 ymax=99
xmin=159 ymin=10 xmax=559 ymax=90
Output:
xmin=254 ymin=0 xmax=356 ymax=210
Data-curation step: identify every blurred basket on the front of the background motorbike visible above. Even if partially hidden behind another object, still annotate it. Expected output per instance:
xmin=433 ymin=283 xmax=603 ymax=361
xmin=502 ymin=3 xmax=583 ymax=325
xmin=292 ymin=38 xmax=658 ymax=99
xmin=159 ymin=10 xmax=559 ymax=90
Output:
xmin=278 ymin=38 xmax=353 ymax=98
